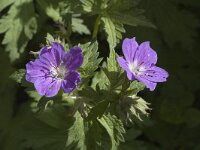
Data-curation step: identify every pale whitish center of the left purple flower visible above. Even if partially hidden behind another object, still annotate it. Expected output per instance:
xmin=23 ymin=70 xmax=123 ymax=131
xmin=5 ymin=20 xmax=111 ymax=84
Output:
xmin=50 ymin=64 xmax=68 ymax=80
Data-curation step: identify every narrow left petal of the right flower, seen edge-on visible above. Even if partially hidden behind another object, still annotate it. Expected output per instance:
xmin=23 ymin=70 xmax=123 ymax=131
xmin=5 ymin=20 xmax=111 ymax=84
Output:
xmin=117 ymin=57 xmax=135 ymax=80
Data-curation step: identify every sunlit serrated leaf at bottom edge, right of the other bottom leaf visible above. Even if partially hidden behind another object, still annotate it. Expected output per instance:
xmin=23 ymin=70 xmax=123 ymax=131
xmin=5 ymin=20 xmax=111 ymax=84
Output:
xmin=98 ymin=114 xmax=125 ymax=150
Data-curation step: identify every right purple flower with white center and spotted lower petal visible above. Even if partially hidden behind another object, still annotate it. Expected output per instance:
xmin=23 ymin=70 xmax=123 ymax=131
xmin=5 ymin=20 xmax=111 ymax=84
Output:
xmin=117 ymin=38 xmax=168 ymax=91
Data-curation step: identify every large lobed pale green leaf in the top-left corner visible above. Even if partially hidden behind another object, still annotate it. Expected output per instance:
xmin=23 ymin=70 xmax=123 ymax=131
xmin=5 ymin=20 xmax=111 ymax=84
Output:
xmin=0 ymin=0 xmax=37 ymax=61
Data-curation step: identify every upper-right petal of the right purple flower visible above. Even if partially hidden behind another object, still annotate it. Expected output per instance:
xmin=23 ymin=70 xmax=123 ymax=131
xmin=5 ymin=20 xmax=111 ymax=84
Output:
xmin=135 ymin=42 xmax=157 ymax=67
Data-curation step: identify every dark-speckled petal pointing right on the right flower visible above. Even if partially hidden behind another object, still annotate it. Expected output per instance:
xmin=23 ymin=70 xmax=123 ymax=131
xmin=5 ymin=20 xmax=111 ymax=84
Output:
xmin=141 ymin=66 xmax=169 ymax=82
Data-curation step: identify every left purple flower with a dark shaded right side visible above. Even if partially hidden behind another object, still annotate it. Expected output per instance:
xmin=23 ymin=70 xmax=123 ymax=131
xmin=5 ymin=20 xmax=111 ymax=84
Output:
xmin=26 ymin=42 xmax=83 ymax=97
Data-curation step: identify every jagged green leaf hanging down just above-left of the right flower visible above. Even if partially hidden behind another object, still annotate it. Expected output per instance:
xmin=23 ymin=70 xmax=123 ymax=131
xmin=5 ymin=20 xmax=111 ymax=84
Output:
xmin=101 ymin=17 xmax=125 ymax=50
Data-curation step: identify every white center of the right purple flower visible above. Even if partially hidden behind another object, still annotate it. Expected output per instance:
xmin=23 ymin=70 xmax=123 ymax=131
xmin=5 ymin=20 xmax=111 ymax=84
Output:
xmin=128 ymin=61 xmax=145 ymax=75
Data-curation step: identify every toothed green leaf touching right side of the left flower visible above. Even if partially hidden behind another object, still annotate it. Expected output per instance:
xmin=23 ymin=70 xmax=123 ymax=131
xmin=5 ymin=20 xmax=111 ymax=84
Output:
xmin=79 ymin=42 xmax=102 ymax=78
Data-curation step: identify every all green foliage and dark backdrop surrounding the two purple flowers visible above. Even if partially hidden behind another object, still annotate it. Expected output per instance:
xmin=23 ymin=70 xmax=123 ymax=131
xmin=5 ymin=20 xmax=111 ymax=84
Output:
xmin=0 ymin=0 xmax=200 ymax=150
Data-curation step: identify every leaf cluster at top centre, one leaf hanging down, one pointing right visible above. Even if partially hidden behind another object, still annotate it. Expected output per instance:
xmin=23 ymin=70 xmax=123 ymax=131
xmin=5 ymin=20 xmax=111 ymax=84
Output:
xmin=81 ymin=0 xmax=155 ymax=49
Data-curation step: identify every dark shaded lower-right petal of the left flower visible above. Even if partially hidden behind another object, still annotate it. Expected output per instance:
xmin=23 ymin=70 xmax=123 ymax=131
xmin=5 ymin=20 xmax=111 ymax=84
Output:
xmin=61 ymin=71 xmax=81 ymax=93
